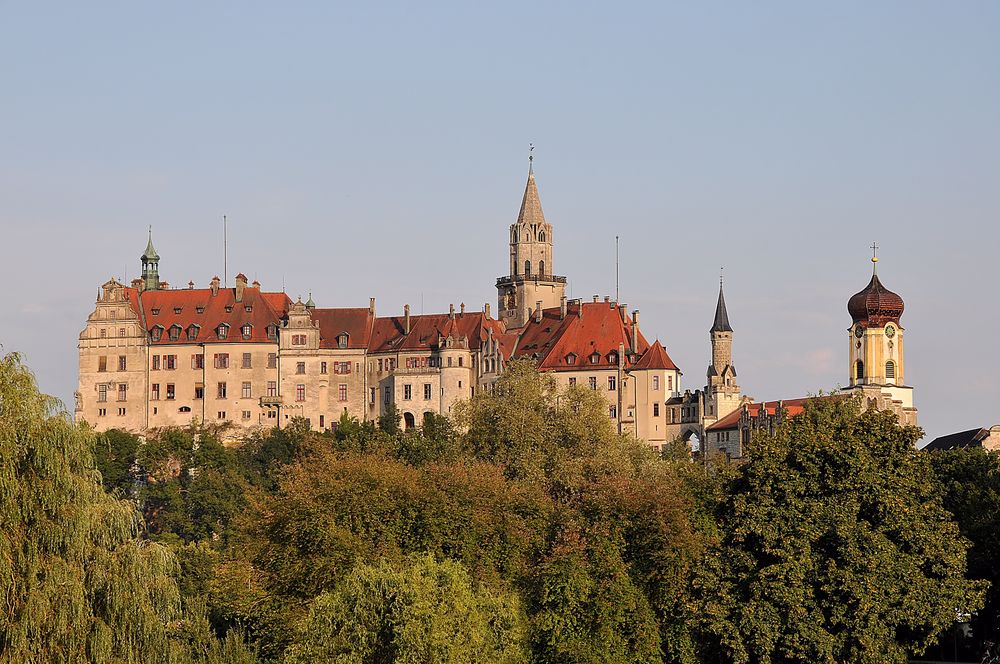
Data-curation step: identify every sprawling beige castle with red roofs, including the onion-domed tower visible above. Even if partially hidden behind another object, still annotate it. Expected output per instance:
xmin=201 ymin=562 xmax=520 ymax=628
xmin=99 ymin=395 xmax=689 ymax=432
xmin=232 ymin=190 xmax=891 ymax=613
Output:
xmin=76 ymin=161 xmax=916 ymax=456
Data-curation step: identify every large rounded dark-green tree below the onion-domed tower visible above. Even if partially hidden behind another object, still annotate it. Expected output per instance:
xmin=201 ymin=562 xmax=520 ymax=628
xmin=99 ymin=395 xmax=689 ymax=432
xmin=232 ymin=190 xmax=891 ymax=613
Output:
xmin=696 ymin=399 xmax=983 ymax=663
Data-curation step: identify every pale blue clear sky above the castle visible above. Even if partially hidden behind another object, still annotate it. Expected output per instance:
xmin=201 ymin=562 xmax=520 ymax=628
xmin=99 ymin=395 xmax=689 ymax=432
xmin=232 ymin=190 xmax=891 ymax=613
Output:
xmin=0 ymin=0 xmax=1000 ymax=444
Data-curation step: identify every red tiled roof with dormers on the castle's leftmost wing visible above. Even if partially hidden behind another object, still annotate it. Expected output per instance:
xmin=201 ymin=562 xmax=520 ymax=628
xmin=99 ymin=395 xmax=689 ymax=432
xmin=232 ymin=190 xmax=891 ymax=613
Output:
xmin=139 ymin=286 xmax=287 ymax=346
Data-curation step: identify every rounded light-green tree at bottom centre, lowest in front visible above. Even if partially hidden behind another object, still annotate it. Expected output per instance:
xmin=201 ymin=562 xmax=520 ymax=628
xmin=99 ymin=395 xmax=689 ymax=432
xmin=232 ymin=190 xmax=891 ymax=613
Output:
xmin=286 ymin=554 xmax=526 ymax=664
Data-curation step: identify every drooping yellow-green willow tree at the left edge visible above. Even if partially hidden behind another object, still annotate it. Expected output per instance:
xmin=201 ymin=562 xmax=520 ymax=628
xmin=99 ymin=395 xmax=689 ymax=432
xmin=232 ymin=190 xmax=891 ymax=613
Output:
xmin=0 ymin=354 xmax=254 ymax=662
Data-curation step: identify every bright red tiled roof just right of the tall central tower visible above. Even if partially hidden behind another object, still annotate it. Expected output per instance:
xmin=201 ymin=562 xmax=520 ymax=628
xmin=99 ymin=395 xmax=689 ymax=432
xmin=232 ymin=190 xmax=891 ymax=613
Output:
xmin=514 ymin=302 xmax=649 ymax=371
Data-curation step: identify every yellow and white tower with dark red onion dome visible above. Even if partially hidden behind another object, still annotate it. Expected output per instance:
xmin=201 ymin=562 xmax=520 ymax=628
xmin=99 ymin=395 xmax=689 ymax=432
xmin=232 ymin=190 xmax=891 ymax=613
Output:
xmin=847 ymin=244 xmax=916 ymax=424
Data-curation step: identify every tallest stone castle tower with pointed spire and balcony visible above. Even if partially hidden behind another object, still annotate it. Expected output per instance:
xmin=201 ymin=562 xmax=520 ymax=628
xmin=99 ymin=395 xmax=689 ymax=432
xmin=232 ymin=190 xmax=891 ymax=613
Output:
xmin=497 ymin=150 xmax=566 ymax=329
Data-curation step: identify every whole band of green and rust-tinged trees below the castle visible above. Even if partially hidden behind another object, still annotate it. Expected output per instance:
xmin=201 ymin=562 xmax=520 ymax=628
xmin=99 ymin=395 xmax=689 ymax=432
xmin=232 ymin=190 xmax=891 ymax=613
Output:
xmin=0 ymin=358 xmax=998 ymax=663
